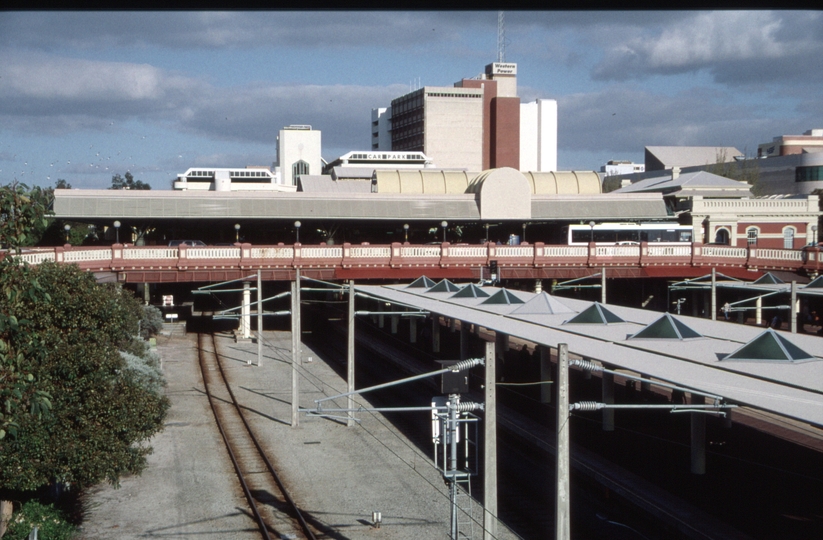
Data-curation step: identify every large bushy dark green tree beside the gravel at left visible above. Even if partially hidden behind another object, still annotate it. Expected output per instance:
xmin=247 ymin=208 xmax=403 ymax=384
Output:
xmin=0 ymin=263 xmax=168 ymax=499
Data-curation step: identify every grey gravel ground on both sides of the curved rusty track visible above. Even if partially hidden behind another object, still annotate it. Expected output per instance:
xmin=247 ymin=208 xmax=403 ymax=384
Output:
xmin=82 ymin=323 xmax=515 ymax=540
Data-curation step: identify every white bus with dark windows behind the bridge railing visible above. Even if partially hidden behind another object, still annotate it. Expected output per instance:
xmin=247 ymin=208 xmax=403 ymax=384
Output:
xmin=564 ymin=223 xmax=692 ymax=246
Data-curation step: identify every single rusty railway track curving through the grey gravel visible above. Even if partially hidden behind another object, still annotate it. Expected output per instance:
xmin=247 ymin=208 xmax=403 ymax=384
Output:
xmin=197 ymin=333 xmax=316 ymax=540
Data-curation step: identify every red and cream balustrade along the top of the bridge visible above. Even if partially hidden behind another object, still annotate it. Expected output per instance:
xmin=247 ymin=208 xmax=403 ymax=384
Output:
xmin=0 ymin=242 xmax=823 ymax=273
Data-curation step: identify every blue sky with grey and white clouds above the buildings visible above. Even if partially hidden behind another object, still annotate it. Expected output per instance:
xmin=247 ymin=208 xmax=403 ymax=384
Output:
xmin=0 ymin=11 xmax=823 ymax=189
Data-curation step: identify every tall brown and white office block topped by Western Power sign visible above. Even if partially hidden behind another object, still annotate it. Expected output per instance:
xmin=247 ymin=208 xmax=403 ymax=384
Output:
xmin=371 ymin=62 xmax=557 ymax=172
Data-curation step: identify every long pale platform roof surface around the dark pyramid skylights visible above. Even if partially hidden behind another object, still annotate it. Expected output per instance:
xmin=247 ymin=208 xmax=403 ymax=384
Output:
xmin=356 ymin=285 xmax=823 ymax=426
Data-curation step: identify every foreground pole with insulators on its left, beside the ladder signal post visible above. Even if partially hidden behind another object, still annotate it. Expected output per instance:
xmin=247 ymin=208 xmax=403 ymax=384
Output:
xmin=483 ymin=341 xmax=497 ymax=540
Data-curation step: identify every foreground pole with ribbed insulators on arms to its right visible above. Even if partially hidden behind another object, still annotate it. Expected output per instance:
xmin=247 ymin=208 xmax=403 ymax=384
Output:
xmin=554 ymin=343 xmax=571 ymax=540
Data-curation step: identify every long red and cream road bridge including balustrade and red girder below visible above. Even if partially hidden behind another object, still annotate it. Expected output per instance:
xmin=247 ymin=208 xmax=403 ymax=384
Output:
xmin=9 ymin=242 xmax=823 ymax=283
